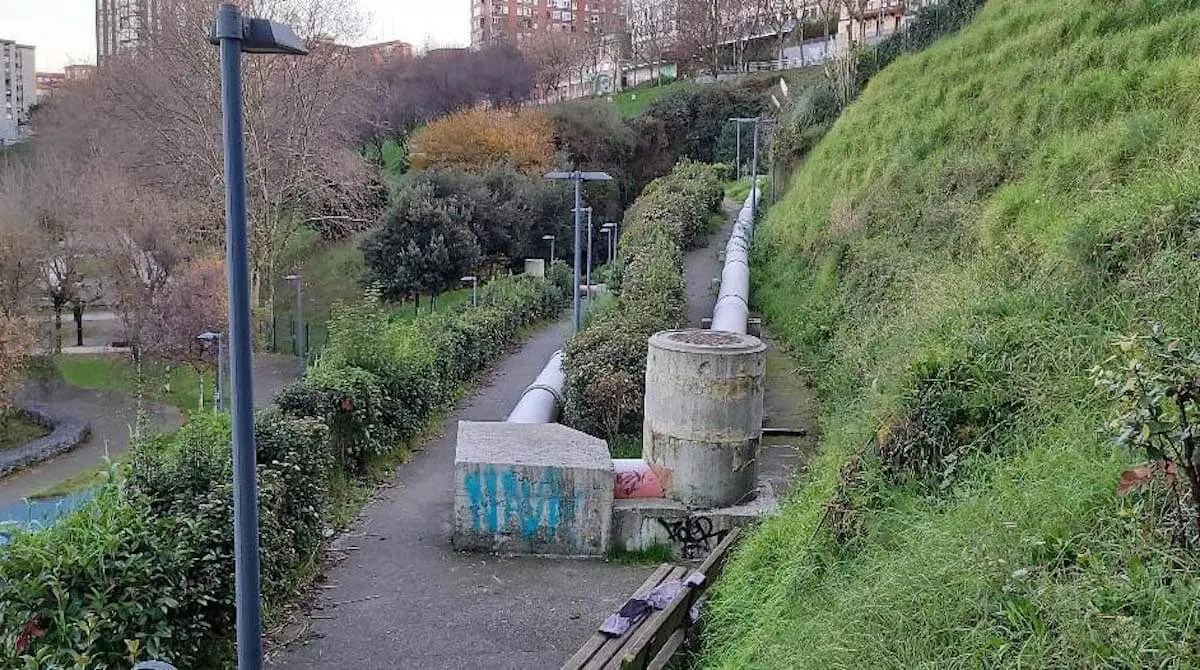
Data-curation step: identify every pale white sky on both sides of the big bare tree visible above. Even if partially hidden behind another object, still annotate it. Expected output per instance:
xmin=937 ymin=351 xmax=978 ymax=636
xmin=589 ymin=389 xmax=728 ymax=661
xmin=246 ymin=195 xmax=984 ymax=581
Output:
xmin=0 ymin=0 xmax=470 ymax=72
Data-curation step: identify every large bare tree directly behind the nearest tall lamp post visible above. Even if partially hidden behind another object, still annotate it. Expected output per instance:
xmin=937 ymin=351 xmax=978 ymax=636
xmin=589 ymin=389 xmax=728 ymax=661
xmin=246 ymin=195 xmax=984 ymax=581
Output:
xmin=38 ymin=0 xmax=373 ymax=316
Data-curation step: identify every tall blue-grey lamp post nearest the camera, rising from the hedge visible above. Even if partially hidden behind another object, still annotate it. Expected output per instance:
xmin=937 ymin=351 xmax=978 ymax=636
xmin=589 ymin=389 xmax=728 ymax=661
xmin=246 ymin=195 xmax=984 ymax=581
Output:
xmin=210 ymin=4 xmax=308 ymax=670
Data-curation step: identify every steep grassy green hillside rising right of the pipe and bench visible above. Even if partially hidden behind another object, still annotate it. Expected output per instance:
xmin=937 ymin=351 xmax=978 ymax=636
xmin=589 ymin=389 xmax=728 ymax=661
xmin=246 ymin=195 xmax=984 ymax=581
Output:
xmin=702 ymin=0 xmax=1200 ymax=669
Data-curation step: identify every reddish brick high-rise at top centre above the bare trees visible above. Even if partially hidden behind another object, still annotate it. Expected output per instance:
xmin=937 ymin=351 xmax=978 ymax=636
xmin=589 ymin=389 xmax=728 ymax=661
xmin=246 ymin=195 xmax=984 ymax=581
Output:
xmin=470 ymin=0 xmax=625 ymax=47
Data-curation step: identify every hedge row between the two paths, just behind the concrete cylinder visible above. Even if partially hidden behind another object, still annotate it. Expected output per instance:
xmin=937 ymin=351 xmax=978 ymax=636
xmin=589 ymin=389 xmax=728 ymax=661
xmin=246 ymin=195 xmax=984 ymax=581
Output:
xmin=563 ymin=161 xmax=722 ymax=438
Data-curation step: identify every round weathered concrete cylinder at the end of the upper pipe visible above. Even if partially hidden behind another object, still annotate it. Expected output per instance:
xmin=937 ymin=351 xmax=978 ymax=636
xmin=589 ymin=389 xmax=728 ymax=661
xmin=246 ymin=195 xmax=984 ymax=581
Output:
xmin=642 ymin=330 xmax=767 ymax=509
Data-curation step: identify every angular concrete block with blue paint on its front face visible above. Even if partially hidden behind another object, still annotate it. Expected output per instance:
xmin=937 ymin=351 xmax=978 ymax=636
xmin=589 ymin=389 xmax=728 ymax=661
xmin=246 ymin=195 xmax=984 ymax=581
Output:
xmin=451 ymin=421 xmax=613 ymax=556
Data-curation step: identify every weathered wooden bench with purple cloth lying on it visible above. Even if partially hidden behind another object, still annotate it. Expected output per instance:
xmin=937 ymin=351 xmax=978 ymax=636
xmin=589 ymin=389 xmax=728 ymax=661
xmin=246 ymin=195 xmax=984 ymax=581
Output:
xmin=563 ymin=528 xmax=740 ymax=670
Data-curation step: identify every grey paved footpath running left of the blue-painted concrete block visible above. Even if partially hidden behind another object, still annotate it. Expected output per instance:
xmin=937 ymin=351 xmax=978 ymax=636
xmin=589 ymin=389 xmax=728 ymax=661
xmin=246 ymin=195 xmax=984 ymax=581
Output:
xmin=271 ymin=322 xmax=650 ymax=670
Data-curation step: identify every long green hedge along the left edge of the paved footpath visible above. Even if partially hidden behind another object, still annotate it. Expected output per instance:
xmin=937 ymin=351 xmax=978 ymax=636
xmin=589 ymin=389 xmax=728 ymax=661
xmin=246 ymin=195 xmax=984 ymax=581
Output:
xmin=0 ymin=265 xmax=570 ymax=670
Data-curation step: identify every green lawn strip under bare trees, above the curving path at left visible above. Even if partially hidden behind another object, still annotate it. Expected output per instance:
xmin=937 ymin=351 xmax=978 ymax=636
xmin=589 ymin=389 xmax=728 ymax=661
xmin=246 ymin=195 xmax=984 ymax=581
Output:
xmin=55 ymin=355 xmax=215 ymax=414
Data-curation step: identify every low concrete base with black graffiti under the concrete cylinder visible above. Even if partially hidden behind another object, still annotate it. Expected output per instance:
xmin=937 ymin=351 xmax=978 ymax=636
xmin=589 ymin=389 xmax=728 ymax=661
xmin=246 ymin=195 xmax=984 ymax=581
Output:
xmin=612 ymin=481 xmax=779 ymax=560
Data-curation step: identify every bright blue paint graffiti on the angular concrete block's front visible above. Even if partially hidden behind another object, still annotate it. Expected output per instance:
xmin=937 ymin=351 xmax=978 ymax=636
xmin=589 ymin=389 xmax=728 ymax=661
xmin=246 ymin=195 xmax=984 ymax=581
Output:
xmin=463 ymin=465 xmax=571 ymax=542
